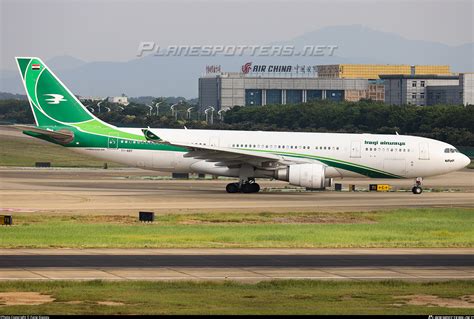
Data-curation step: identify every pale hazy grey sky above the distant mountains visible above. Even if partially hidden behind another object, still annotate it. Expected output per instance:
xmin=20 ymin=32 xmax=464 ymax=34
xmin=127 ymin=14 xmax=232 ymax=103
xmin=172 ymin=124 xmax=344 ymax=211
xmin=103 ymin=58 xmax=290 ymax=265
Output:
xmin=0 ymin=0 xmax=474 ymax=69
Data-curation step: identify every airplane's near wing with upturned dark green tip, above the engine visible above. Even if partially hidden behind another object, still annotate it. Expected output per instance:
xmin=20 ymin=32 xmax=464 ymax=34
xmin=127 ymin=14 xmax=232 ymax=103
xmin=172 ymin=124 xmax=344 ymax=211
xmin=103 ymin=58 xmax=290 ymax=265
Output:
xmin=143 ymin=129 xmax=308 ymax=170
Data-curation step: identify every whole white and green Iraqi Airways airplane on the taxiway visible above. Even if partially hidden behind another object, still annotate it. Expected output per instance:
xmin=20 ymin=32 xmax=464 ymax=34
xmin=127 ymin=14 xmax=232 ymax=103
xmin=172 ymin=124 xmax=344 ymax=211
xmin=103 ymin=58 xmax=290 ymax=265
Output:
xmin=16 ymin=57 xmax=470 ymax=194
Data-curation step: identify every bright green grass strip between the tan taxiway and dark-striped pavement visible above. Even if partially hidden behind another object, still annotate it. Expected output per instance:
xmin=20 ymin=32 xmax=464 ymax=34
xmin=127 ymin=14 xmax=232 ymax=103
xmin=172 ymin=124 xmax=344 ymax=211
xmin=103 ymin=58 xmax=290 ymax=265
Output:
xmin=0 ymin=208 xmax=474 ymax=248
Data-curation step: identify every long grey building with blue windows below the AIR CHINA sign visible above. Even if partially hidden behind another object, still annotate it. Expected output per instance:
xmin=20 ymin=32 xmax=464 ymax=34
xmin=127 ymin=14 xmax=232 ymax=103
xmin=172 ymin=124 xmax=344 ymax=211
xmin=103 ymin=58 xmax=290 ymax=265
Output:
xmin=199 ymin=73 xmax=376 ymax=110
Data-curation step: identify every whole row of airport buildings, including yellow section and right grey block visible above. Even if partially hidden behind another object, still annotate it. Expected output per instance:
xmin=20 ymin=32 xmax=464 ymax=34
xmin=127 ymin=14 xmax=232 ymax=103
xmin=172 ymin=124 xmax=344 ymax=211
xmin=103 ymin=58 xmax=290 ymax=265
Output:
xmin=199 ymin=62 xmax=474 ymax=110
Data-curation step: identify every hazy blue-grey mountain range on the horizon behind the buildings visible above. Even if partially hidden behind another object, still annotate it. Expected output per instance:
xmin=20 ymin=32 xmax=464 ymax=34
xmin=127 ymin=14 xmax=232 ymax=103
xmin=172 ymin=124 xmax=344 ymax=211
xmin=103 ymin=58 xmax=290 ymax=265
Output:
xmin=0 ymin=25 xmax=474 ymax=98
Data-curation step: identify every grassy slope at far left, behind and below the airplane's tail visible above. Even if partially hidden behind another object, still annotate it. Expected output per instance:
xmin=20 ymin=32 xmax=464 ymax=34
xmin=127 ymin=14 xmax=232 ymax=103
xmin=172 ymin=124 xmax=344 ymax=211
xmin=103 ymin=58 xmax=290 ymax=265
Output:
xmin=0 ymin=135 xmax=119 ymax=167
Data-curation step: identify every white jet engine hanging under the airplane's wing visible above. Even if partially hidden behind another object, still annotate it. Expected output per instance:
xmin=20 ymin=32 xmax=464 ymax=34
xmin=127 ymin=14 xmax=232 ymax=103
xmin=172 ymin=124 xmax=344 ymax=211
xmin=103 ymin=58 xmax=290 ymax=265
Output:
xmin=275 ymin=164 xmax=332 ymax=189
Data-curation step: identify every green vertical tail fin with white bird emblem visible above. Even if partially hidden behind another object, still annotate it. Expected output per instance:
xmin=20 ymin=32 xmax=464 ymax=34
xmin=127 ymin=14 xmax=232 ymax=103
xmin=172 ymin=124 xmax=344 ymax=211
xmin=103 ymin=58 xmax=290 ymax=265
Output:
xmin=16 ymin=57 xmax=96 ymax=126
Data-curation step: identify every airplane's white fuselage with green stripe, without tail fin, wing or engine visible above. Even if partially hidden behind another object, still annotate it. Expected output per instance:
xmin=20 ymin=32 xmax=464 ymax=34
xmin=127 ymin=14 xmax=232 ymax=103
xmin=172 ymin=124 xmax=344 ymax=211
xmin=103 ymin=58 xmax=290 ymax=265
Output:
xmin=74 ymin=128 xmax=468 ymax=178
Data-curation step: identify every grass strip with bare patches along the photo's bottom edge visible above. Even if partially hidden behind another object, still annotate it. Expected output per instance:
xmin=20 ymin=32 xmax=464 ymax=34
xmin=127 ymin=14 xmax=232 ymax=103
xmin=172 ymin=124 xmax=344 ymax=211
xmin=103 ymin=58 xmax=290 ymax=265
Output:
xmin=0 ymin=281 xmax=474 ymax=315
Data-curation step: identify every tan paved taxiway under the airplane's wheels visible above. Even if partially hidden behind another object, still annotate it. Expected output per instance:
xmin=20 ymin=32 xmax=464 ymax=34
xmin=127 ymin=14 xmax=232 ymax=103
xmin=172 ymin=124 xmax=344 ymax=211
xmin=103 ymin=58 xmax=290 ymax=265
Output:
xmin=0 ymin=168 xmax=474 ymax=214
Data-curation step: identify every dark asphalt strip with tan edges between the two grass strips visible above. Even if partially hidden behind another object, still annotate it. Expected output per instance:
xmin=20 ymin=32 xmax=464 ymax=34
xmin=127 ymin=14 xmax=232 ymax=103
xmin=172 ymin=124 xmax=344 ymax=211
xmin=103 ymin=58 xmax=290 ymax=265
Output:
xmin=0 ymin=248 xmax=474 ymax=282
